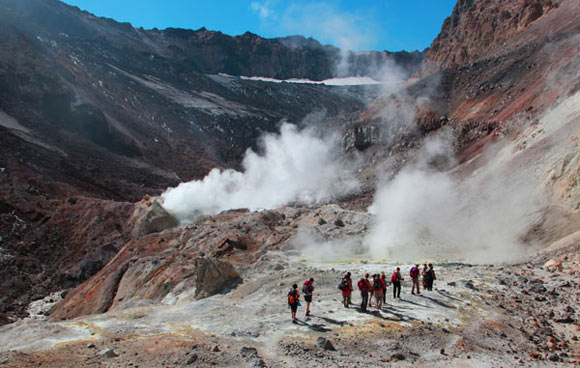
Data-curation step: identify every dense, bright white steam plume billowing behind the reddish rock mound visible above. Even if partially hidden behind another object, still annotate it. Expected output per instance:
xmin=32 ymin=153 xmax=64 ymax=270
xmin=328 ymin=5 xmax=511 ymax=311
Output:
xmin=161 ymin=124 xmax=358 ymax=222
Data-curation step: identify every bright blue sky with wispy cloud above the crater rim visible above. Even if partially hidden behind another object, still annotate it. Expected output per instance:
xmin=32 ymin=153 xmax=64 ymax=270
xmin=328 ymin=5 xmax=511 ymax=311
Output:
xmin=64 ymin=0 xmax=457 ymax=51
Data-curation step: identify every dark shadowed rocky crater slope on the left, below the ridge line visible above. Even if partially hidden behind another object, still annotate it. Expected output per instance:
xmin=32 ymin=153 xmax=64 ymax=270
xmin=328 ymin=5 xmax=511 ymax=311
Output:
xmin=0 ymin=0 xmax=412 ymax=316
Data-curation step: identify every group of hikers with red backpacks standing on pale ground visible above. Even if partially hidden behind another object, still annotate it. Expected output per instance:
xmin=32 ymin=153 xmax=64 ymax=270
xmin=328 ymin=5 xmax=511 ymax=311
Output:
xmin=288 ymin=263 xmax=437 ymax=323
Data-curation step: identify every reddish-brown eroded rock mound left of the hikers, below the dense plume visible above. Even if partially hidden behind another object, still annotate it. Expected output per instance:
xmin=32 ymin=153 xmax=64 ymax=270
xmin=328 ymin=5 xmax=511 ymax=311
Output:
xmin=51 ymin=211 xmax=296 ymax=320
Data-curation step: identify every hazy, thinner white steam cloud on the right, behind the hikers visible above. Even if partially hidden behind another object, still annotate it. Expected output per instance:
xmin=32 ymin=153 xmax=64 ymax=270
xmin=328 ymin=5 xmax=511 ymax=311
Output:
xmin=366 ymin=140 xmax=542 ymax=263
